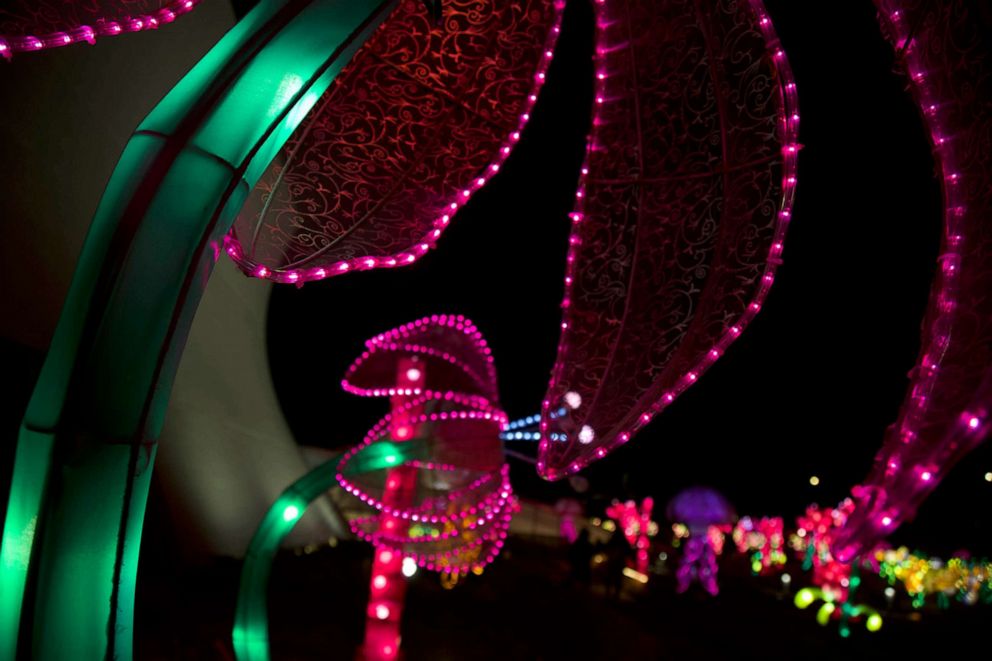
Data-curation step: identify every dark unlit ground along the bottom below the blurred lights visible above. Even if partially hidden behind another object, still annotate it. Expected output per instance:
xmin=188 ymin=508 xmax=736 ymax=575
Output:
xmin=136 ymin=537 xmax=990 ymax=661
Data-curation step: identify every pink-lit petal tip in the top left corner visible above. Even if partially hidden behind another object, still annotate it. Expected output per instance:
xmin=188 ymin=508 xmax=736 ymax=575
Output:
xmin=0 ymin=0 xmax=201 ymax=60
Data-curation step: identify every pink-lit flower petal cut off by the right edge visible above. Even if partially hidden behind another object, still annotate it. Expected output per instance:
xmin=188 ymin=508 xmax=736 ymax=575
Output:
xmin=833 ymin=0 xmax=992 ymax=561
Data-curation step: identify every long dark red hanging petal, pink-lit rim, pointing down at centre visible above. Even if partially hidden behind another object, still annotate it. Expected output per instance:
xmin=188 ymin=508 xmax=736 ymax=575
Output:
xmin=537 ymin=0 xmax=799 ymax=479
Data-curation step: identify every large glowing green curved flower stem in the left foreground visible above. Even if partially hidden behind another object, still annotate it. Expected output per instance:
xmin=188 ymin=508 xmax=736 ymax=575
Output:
xmin=0 ymin=0 xmax=395 ymax=659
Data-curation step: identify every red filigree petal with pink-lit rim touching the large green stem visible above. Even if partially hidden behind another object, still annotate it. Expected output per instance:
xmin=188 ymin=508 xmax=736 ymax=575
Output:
xmin=227 ymin=0 xmax=564 ymax=283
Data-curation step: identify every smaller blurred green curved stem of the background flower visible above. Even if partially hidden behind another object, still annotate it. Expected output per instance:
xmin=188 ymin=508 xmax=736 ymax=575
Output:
xmin=231 ymin=439 xmax=426 ymax=661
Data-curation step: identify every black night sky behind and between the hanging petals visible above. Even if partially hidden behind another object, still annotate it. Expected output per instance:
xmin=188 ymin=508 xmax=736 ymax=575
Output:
xmin=268 ymin=0 xmax=992 ymax=553
